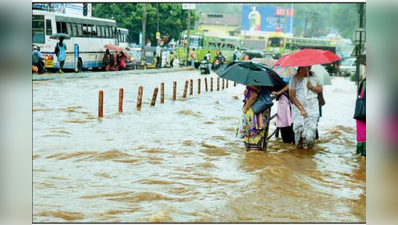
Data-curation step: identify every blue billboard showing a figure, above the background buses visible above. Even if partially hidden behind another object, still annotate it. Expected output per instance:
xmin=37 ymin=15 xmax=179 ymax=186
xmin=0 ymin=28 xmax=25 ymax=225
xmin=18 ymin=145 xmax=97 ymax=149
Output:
xmin=242 ymin=5 xmax=293 ymax=33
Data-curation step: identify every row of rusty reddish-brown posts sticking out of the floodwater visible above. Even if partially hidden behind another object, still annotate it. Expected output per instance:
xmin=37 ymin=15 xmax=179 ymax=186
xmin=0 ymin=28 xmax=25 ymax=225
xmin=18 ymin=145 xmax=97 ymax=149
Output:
xmin=98 ymin=77 xmax=237 ymax=118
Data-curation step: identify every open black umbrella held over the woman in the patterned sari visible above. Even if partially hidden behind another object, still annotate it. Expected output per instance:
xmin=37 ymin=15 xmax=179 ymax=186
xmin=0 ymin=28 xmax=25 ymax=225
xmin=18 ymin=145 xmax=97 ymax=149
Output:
xmin=215 ymin=61 xmax=284 ymax=87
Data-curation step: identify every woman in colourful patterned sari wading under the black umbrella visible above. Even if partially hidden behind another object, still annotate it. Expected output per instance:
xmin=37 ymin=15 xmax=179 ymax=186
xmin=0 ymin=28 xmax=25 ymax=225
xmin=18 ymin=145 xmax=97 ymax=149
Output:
xmin=242 ymin=85 xmax=268 ymax=151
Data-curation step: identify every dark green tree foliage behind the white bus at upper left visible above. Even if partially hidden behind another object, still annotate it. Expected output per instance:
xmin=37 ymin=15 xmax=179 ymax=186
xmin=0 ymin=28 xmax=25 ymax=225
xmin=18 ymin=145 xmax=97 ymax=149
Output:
xmin=93 ymin=3 xmax=198 ymax=43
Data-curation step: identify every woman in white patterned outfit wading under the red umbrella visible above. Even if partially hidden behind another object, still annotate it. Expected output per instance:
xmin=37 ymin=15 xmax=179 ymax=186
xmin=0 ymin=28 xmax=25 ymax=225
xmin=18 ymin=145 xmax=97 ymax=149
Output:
xmin=289 ymin=66 xmax=323 ymax=149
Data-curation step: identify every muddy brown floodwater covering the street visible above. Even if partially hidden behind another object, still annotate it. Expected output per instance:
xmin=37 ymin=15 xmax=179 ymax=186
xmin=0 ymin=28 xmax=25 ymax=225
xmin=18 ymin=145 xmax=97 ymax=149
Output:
xmin=33 ymin=71 xmax=366 ymax=222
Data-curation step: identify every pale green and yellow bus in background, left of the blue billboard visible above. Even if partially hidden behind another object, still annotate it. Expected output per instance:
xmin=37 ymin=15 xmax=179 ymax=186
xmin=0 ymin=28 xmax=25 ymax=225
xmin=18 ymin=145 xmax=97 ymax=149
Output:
xmin=176 ymin=30 xmax=242 ymax=62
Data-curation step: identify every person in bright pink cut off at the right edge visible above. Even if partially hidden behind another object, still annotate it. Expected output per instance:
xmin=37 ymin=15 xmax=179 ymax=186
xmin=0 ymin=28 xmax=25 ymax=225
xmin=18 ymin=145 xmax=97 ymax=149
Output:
xmin=356 ymin=74 xmax=366 ymax=159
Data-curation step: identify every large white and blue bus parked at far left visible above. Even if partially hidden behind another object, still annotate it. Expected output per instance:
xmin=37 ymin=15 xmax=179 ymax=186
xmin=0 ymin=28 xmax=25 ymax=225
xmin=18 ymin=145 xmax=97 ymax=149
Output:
xmin=32 ymin=10 xmax=118 ymax=72
